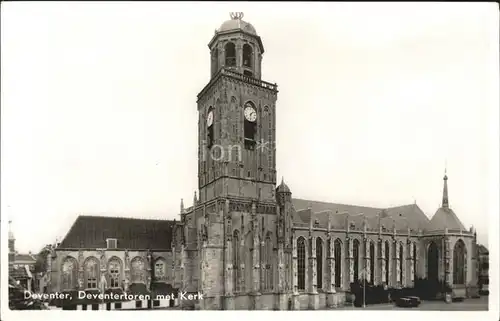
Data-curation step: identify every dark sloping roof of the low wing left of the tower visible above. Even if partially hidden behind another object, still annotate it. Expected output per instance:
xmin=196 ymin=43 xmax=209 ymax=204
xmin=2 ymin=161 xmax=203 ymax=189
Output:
xmin=58 ymin=215 xmax=175 ymax=250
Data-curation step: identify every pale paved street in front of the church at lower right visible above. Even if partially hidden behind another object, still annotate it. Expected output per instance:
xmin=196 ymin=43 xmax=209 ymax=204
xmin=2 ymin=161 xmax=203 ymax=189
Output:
xmin=341 ymin=296 xmax=488 ymax=311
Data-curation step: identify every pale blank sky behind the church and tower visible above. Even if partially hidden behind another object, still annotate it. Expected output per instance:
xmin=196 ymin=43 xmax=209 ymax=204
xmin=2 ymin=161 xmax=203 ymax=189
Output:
xmin=1 ymin=2 xmax=499 ymax=252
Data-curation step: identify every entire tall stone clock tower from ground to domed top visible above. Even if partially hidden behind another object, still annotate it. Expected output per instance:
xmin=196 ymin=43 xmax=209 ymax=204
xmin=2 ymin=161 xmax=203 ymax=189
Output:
xmin=195 ymin=13 xmax=283 ymax=310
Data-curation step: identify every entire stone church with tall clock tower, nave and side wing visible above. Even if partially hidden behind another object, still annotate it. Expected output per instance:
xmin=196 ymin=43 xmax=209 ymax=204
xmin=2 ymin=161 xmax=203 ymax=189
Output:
xmin=48 ymin=13 xmax=478 ymax=310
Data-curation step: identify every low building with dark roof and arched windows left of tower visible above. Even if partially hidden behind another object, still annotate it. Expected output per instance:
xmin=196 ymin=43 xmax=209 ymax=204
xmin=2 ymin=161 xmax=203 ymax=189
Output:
xmin=47 ymin=215 xmax=180 ymax=299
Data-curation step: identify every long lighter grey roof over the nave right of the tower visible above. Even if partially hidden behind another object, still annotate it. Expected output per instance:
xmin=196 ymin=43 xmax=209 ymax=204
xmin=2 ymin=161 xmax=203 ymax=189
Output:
xmin=292 ymin=198 xmax=429 ymax=231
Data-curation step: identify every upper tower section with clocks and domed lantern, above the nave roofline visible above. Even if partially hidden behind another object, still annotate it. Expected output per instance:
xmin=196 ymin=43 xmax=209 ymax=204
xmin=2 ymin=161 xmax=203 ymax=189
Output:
xmin=198 ymin=13 xmax=278 ymax=202
